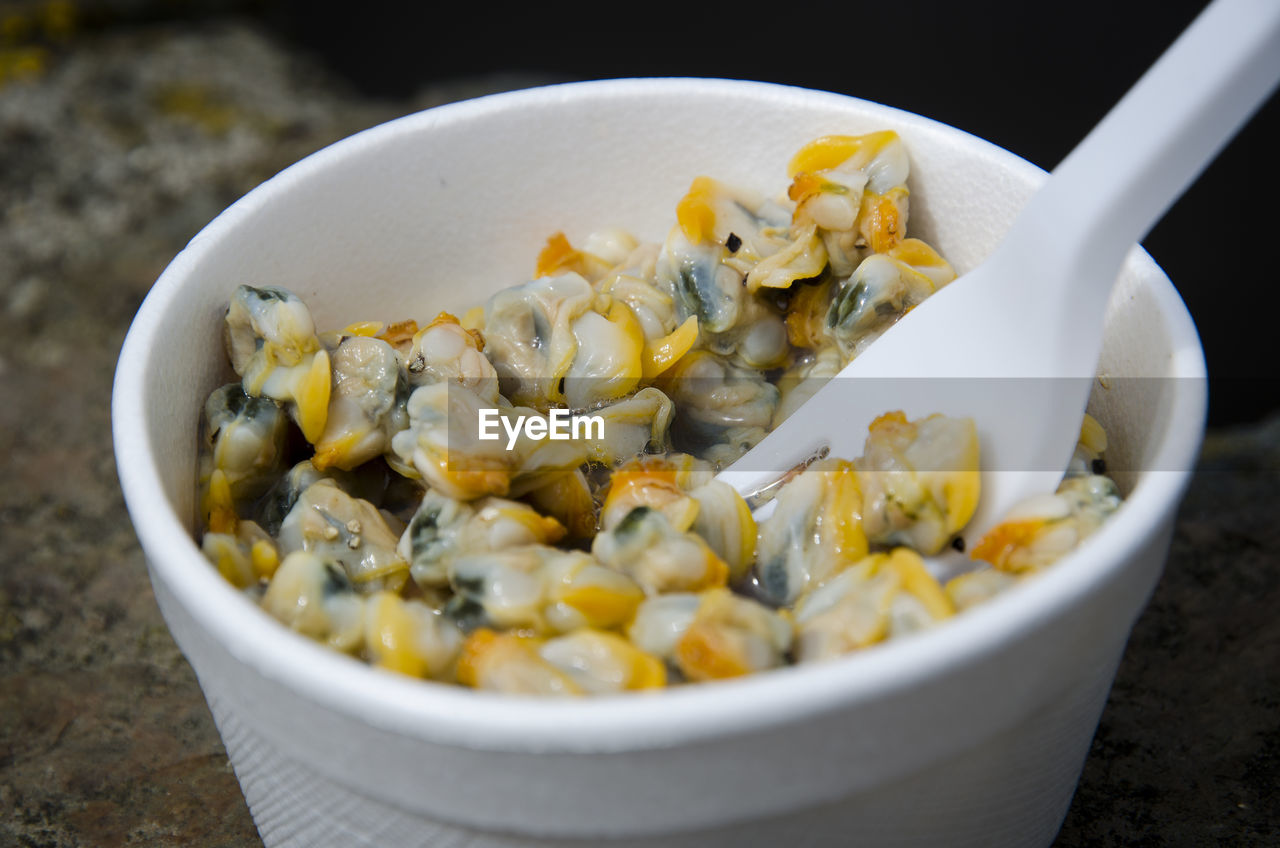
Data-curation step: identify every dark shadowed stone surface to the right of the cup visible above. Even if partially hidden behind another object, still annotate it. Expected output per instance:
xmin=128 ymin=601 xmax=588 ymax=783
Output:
xmin=1057 ymin=419 xmax=1280 ymax=848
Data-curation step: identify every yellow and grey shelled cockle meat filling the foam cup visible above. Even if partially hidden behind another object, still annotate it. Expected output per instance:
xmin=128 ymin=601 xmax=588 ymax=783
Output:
xmin=189 ymin=132 xmax=1120 ymax=694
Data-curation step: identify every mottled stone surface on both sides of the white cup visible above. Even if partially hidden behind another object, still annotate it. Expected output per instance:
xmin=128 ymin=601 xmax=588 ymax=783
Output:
xmin=0 ymin=13 xmax=1280 ymax=848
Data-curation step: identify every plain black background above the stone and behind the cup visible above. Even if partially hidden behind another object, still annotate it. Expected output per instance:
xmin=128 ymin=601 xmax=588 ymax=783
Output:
xmin=45 ymin=0 xmax=1280 ymax=425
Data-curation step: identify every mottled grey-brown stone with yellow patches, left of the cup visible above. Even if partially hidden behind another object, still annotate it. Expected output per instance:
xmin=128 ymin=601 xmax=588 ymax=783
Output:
xmin=0 ymin=22 xmax=545 ymax=847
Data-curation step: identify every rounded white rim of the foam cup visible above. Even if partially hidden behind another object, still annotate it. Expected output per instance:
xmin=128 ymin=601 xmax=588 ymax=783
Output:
xmin=111 ymin=77 xmax=1206 ymax=752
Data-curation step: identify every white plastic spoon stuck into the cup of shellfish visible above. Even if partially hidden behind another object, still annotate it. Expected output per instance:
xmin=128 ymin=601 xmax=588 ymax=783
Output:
xmin=719 ymin=0 xmax=1280 ymax=568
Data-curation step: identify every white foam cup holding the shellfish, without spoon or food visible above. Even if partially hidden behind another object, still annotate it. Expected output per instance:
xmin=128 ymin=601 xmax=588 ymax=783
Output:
xmin=113 ymin=79 xmax=1206 ymax=848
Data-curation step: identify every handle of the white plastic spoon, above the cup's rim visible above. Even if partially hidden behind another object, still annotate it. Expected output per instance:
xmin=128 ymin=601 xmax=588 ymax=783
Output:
xmin=992 ymin=0 xmax=1280 ymax=333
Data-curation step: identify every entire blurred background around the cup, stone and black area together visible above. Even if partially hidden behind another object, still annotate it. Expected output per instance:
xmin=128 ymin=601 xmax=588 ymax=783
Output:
xmin=0 ymin=0 xmax=1280 ymax=848
